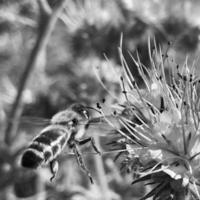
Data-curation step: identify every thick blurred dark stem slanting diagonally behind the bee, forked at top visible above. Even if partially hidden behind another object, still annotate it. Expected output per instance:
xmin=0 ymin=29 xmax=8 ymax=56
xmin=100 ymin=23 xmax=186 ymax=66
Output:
xmin=5 ymin=0 xmax=66 ymax=145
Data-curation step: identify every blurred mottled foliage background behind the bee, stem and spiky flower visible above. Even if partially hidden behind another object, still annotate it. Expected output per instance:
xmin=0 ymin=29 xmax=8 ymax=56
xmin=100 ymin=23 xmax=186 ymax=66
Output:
xmin=0 ymin=0 xmax=200 ymax=200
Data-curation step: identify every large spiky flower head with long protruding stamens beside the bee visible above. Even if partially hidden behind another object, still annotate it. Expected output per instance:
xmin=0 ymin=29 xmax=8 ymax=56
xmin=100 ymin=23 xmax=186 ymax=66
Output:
xmin=101 ymin=38 xmax=200 ymax=200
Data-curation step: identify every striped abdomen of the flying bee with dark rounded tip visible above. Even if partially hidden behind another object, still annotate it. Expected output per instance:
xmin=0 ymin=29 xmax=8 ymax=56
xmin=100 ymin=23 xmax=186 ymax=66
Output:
xmin=21 ymin=125 xmax=71 ymax=168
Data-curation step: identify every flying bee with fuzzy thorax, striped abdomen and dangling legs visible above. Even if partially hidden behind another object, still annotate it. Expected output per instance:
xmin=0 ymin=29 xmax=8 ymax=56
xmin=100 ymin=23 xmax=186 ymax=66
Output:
xmin=21 ymin=104 xmax=100 ymax=183
